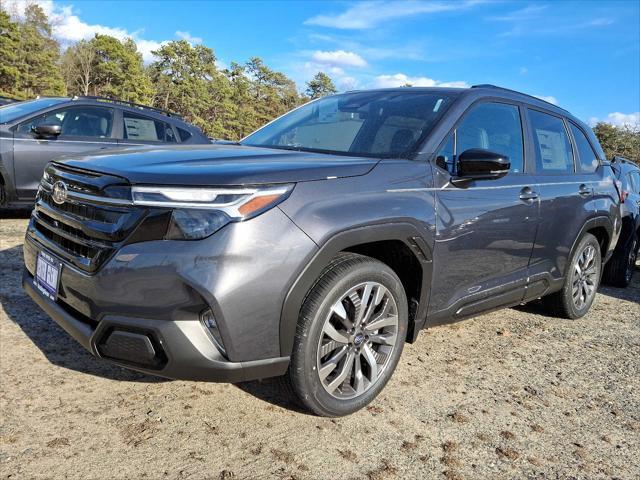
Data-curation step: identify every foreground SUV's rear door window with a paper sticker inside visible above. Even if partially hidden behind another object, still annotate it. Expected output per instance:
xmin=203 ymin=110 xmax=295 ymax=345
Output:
xmin=529 ymin=110 xmax=573 ymax=173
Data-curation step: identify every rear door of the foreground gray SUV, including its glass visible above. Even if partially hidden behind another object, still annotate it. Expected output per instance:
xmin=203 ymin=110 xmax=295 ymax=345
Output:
xmin=527 ymin=108 xmax=604 ymax=294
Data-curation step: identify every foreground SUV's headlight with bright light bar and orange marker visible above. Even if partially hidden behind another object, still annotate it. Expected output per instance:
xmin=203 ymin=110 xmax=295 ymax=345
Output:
xmin=131 ymin=185 xmax=293 ymax=240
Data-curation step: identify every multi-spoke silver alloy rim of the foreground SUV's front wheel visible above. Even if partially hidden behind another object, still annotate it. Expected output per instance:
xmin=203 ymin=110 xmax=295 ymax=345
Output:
xmin=317 ymin=282 xmax=398 ymax=400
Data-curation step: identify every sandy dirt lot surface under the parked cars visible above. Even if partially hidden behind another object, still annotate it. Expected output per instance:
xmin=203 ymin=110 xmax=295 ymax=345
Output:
xmin=0 ymin=219 xmax=640 ymax=479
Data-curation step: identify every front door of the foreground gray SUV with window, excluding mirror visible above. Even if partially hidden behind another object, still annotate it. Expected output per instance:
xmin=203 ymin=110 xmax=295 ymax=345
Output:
xmin=429 ymin=102 xmax=539 ymax=323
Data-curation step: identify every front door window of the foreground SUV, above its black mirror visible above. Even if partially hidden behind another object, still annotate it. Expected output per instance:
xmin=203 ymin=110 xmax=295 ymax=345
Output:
xmin=456 ymin=103 xmax=524 ymax=173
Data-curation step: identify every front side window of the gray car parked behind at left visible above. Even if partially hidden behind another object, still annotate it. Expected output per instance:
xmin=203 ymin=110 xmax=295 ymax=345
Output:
xmin=17 ymin=106 xmax=113 ymax=138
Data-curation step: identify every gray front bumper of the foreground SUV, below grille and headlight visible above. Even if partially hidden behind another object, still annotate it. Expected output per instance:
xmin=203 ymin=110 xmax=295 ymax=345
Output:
xmin=22 ymin=208 xmax=317 ymax=382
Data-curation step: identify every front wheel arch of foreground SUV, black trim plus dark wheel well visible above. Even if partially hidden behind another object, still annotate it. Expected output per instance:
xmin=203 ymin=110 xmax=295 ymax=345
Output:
xmin=280 ymin=222 xmax=432 ymax=356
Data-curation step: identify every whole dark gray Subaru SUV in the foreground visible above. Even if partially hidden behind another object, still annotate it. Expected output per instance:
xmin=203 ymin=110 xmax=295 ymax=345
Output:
xmin=23 ymin=86 xmax=620 ymax=416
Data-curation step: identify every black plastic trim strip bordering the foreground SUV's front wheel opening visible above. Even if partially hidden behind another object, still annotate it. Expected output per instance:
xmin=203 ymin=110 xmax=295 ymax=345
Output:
xmin=280 ymin=221 xmax=432 ymax=357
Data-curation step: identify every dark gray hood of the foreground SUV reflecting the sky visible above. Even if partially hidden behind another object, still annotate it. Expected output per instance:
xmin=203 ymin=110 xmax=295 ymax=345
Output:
xmin=57 ymin=145 xmax=378 ymax=185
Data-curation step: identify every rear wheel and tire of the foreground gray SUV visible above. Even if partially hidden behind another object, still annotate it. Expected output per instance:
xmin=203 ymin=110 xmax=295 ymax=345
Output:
xmin=542 ymin=233 xmax=602 ymax=320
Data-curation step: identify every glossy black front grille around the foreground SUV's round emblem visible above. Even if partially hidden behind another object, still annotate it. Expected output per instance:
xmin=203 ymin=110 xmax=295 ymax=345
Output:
xmin=28 ymin=164 xmax=145 ymax=273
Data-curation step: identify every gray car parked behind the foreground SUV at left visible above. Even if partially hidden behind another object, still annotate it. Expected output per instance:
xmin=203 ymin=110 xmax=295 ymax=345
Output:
xmin=0 ymin=97 xmax=209 ymax=207
